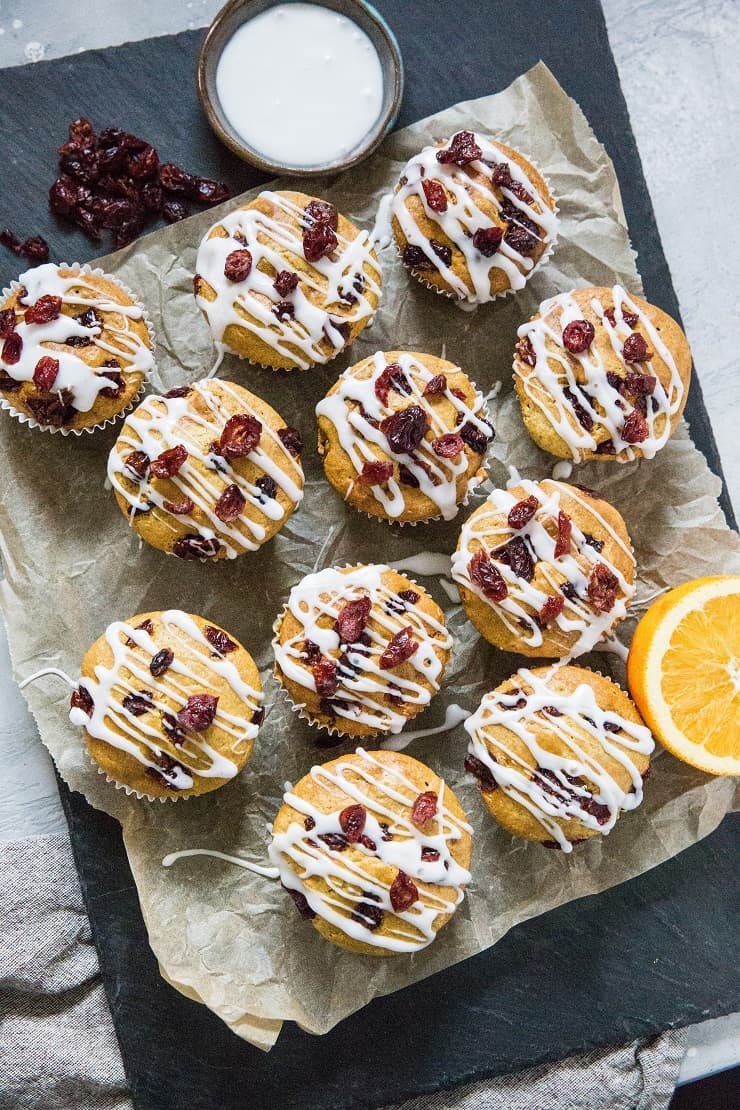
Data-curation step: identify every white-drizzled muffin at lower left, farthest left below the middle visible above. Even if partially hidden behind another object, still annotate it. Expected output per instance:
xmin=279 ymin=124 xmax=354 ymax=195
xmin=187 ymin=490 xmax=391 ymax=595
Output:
xmin=70 ymin=609 xmax=264 ymax=799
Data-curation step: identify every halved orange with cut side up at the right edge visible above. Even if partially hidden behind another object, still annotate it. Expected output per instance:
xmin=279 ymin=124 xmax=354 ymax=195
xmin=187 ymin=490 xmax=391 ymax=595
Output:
xmin=627 ymin=575 xmax=740 ymax=775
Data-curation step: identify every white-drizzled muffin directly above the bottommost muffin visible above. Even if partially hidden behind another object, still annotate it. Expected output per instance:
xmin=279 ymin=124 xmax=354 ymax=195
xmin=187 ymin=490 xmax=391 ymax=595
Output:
xmin=273 ymin=565 xmax=453 ymax=737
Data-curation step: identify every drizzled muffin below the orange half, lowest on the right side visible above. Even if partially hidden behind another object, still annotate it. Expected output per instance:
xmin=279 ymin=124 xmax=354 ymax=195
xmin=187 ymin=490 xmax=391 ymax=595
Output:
xmin=465 ymin=666 xmax=655 ymax=852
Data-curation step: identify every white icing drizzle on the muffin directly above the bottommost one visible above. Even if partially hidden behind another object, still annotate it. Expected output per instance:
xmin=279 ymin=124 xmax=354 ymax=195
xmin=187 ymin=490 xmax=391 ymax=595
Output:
xmin=273 ymin=565 xmax=453 ymax=733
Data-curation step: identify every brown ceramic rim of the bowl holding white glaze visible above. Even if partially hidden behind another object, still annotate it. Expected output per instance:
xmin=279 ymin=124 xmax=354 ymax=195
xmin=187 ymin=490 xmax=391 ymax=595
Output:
xmin=196 ymin=0 xmax=404 ymax=178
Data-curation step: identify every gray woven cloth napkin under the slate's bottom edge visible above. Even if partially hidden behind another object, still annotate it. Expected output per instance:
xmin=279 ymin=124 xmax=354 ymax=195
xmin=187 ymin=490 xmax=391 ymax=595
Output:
xmin=0 ymin=834 xmax=686 ymax=1110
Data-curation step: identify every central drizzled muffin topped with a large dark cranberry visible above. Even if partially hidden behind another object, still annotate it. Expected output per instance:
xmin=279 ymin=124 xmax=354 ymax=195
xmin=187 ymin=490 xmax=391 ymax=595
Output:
xmin=316 ymin=351 xmax=494 ymax=523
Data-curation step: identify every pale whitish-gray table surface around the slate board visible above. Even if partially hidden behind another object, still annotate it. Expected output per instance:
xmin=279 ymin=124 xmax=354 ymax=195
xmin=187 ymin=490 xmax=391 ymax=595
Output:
xmin=0 ymin=0 xmax=740 ymax=1082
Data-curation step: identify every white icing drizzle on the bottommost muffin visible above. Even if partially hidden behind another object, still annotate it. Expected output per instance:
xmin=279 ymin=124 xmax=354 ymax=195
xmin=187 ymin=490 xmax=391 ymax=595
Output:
xmin=268 ymin=748 xmax=472 ymax=952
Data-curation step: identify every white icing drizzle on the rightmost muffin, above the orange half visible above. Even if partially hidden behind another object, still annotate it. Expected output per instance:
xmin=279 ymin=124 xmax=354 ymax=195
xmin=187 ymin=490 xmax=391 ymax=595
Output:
xmin=514 ymin=285 xmax=685 ymax=462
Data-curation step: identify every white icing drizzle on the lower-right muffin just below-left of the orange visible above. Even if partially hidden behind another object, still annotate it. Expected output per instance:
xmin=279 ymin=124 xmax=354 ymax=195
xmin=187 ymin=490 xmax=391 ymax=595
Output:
xmin=465 ymin=667 xmax=655 ymax=852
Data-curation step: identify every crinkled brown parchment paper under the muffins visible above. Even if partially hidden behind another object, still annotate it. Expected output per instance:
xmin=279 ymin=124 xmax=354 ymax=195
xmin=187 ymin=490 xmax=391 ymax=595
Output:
xmin=0 ymin=64 xmax=740 ymax=1048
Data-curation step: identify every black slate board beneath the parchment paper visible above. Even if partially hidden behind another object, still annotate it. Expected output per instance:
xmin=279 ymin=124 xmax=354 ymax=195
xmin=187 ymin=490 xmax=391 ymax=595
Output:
xmin=0 ymin=0 xmax=740 ymax=1110
